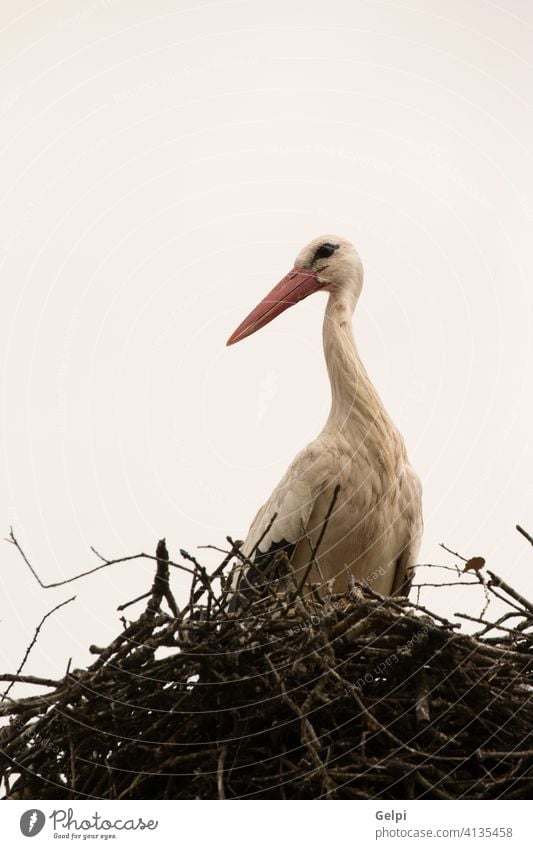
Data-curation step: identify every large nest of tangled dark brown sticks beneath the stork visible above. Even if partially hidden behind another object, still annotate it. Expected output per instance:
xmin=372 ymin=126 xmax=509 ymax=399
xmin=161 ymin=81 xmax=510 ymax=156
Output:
xmin=0 ymin=540 xmax=533 ymax=799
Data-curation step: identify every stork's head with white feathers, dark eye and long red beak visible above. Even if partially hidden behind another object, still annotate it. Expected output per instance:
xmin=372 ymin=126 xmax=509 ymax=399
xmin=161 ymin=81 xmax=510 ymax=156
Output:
xmin=226 ymin=236 xmax=363 ymax=345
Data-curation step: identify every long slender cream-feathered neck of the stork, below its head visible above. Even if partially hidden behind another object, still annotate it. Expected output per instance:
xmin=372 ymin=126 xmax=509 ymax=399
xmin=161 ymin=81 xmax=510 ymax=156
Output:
xmin=323 ymin=290 xmax=401 ymax=467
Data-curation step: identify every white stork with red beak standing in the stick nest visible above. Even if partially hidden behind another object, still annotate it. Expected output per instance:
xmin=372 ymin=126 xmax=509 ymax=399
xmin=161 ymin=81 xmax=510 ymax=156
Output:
xmin=227 ymin=236 xmax=422 ymax=595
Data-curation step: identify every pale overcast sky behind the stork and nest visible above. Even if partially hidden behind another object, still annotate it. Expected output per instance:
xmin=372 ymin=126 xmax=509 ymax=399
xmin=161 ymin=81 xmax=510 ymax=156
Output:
xmin=0 ymin=0 xmax=533 ymax=688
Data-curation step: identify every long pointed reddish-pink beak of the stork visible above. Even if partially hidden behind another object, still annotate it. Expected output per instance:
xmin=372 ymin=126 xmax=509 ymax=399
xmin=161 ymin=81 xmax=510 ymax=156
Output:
xmin=226 ymin=267 xmax=324 ymax=345
